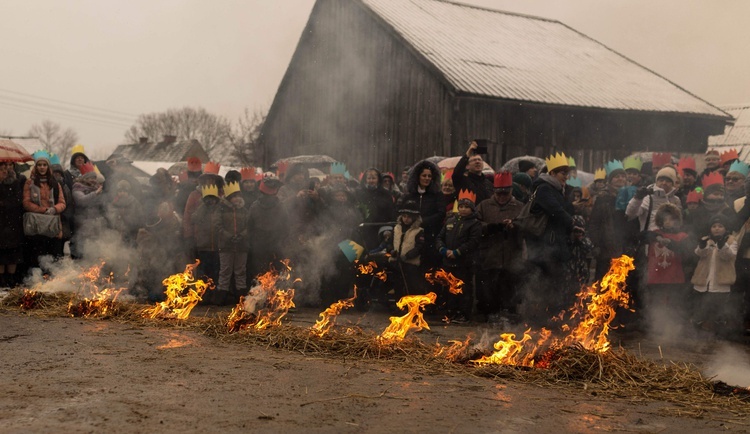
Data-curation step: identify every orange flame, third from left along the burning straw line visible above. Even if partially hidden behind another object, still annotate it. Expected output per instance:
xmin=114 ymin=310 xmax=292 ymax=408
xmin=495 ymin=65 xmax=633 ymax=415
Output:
xmin=227 ymin=259 xmax=300 ymax=333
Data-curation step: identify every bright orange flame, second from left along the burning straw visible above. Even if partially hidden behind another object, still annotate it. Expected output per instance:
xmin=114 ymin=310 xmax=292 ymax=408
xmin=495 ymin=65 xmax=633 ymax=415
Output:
xmin=142 ymin=261 xmax=214 ymax=319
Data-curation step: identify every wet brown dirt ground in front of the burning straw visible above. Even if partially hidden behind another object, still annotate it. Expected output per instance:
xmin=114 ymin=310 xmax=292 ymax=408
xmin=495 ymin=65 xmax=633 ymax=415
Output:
xmin=0 ymin=302 xmax=750 ymax=433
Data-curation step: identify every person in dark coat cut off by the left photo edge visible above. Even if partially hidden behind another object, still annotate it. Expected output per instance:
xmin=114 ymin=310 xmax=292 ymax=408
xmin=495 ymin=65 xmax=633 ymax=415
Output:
xmin=0 ymin=160 xmax=26 ymax=287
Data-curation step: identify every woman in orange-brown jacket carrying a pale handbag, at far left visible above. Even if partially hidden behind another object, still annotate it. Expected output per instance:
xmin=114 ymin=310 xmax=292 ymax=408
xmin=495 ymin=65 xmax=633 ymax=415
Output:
xmin=23 ymin=151 xmax=65 ymax=267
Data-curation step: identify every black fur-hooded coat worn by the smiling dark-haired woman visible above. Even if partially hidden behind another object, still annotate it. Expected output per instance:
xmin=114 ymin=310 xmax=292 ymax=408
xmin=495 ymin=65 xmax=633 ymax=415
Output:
xmin=399 ymin=160 xmax=446 ymax=249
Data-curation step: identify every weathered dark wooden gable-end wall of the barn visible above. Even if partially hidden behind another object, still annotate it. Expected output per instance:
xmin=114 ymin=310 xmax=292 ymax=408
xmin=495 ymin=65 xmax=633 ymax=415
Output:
xmin=262 ymin=0 xmax=451 ymax=174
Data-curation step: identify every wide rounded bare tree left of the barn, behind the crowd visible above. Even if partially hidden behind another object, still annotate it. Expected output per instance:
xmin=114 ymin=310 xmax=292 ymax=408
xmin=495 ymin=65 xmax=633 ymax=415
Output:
xmin=125 ymin=107 xmax=232 ymax=155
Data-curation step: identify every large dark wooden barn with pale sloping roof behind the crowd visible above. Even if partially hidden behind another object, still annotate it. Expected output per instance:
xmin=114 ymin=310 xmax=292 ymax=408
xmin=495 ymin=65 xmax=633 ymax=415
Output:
xmin=258 ymin=0 xmax=731 ymax=173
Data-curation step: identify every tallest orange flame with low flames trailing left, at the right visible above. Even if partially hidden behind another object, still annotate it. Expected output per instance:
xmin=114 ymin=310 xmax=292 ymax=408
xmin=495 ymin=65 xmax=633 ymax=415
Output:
xmin=473 ymin=255 xmax=635 ymax=367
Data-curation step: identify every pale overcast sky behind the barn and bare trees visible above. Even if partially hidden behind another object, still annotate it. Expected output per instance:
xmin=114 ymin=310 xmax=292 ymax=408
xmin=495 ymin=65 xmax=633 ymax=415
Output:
xmin=0 ymin=0 xmax=750 ymax=158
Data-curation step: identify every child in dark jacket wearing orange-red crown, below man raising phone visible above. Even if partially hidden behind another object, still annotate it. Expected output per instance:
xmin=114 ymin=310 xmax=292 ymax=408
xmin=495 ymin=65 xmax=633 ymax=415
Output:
xmin=435 ymin=190 xmax=482 ymax=323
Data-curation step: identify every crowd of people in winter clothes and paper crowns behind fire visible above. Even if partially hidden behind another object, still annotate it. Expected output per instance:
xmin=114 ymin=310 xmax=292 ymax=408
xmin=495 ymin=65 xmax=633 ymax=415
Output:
xmin=0 ymin=142 xmax=750 ymax=334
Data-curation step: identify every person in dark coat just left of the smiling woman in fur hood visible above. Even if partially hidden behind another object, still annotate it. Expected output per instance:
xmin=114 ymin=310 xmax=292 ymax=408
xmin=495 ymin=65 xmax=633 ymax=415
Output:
xmin=356 ymin=167 xmax=396 ymax=249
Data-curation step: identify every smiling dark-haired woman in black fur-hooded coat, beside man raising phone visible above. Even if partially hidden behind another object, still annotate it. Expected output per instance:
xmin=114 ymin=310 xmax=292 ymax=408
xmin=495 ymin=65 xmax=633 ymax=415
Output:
xmin=399 ymin=160 xmax=446 ymax=270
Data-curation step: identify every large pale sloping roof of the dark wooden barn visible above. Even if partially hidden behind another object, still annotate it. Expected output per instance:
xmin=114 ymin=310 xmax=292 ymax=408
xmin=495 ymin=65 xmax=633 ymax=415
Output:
xmin=361 ymin=0 xmax=728 ymax=119
